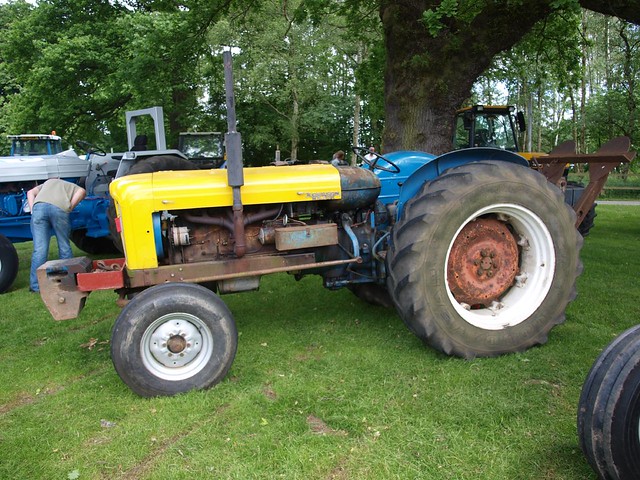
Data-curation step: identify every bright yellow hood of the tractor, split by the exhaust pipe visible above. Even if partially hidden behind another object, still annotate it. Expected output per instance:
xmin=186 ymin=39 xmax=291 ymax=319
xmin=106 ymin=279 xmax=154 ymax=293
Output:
xmin=109 ymin=165 xmax=341 ymax=269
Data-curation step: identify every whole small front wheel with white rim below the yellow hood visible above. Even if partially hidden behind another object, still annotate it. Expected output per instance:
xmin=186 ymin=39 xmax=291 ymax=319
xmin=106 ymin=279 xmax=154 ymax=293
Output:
xmin=111 ymin=283 xmax=238 ymax=397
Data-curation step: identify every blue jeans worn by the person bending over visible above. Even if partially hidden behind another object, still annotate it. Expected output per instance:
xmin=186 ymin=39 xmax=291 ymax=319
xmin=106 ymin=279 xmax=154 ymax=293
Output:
xmin=29 ymin=202 xmax=73 ymax=292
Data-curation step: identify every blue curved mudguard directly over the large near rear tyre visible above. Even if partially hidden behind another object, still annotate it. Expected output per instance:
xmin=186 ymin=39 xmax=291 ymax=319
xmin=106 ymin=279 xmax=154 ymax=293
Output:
xmin=396 ymin=147 xmax=529 ymax=218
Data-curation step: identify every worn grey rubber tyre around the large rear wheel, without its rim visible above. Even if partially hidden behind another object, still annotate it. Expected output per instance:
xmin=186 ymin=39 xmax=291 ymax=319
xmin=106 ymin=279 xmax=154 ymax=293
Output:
xmin=389 ymin=162 xmax=579 ymax=358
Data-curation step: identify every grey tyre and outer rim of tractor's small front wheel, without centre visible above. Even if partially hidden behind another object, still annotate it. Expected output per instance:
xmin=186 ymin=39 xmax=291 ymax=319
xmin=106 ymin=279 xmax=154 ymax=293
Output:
xmin=111 ymin=284 xmax=238 ymax=397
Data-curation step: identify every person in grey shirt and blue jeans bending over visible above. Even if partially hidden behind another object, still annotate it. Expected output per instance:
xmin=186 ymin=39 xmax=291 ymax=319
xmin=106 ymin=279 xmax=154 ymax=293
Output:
xmin=27 ymin=178 xmax=86 ymax=292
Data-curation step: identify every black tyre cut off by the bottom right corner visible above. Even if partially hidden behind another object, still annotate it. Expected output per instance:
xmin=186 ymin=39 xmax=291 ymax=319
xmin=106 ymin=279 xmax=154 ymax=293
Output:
xmin=578 ymin=325 xmax=640 ymax=480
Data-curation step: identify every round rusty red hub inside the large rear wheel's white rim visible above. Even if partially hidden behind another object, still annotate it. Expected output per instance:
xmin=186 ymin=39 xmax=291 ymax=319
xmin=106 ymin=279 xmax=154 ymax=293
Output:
xmin=447 ymin=218 xmax=518 ymax=306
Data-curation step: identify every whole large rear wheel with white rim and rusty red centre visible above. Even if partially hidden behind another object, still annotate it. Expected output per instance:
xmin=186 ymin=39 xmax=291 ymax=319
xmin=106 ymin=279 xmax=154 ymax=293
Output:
xmin=387 ymin=161 xmax=582 ymax=358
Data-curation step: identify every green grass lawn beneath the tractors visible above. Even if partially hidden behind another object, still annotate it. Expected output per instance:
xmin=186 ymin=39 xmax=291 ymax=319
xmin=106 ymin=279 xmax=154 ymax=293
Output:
xmin=0 ymin=205 xmax=640 ymax=480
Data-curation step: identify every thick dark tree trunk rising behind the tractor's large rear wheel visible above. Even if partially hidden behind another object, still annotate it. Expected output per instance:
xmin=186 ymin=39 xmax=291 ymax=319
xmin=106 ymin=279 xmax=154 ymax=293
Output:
xmin=380 ymin=0 xmax=638 ymax=154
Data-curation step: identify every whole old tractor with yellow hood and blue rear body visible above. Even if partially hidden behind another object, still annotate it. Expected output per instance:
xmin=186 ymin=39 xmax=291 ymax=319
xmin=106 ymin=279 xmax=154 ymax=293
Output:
xmin=38 ymin=52 xmax=636 ymax=396
